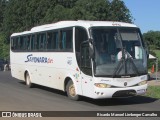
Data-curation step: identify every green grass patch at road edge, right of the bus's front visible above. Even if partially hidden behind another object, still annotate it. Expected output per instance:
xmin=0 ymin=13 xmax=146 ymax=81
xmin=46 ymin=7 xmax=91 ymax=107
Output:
xmin=145 ymin=86 xmax=160 ymax=99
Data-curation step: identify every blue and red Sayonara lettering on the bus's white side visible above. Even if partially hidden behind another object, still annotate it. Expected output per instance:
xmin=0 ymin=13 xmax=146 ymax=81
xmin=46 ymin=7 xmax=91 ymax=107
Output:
xmin=25 ymin=54 xmax=53 ymax=63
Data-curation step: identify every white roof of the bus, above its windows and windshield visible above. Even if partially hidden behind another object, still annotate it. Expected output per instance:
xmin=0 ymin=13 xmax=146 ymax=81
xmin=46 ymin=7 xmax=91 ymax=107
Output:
xmin=11 ymin=20 xmax=137 ymax=36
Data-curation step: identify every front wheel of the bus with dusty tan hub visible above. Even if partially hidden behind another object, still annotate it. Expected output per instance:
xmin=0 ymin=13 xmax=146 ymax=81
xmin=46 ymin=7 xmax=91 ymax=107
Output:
xmin=66 ymin=80 xmax=79 ymax=100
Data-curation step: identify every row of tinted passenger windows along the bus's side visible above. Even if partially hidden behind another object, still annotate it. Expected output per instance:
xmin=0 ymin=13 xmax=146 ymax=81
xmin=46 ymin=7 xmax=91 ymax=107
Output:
xmin=11 ymin=28 xmax=73 ymax=52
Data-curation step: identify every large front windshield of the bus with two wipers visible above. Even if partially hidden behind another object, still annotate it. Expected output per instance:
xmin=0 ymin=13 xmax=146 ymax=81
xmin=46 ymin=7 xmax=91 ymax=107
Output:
xmin=91 ymin=27 xmax=147 ymax=77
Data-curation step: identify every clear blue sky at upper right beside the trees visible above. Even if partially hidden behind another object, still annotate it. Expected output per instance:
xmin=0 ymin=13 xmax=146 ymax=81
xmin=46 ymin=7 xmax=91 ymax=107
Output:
xmin=123 ymin=0 xmax=160 ymax=33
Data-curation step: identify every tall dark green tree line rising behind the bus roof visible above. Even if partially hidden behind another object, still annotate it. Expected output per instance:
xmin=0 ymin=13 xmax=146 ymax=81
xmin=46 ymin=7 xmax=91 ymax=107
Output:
xmin=0 ymin=0 xmax=133 ymax=58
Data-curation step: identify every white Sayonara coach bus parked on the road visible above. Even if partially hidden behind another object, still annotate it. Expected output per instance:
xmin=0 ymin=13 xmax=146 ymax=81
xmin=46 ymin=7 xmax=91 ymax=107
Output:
xmin=10 ymin=20 xmax=147 ymax=100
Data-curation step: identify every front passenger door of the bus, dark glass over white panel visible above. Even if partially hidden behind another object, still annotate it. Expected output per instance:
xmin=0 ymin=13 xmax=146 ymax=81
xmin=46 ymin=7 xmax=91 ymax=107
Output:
xmin=80 ymin=43 xmax=94 ymax=96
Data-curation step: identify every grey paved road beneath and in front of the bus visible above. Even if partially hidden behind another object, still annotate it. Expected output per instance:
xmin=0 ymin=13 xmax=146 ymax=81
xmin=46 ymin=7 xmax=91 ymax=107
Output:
xmin=0 ymin=72 xmax=160 ymax=120
